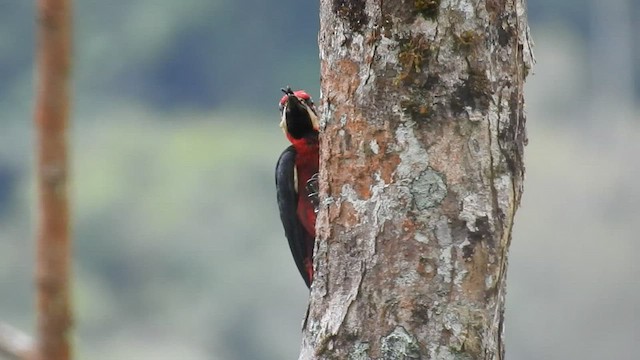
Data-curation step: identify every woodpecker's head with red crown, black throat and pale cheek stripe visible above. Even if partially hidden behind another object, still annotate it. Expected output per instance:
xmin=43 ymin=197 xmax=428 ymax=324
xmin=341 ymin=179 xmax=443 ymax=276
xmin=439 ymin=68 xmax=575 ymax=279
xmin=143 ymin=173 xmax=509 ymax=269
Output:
xmin=280 ymin=86 xmax=320 ymax=140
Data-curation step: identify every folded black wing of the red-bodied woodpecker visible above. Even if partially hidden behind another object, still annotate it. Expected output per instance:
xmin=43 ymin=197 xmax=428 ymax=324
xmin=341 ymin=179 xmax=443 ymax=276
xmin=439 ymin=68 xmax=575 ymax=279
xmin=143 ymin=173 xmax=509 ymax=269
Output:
xmin=276 ymin=146 xmax=310 ymax=287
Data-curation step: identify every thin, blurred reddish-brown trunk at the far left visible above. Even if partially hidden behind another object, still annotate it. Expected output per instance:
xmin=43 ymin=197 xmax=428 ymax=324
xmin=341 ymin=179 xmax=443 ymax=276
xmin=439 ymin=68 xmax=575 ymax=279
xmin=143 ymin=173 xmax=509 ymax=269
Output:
xmin=35 ymin=0 xmax=72 ymax=360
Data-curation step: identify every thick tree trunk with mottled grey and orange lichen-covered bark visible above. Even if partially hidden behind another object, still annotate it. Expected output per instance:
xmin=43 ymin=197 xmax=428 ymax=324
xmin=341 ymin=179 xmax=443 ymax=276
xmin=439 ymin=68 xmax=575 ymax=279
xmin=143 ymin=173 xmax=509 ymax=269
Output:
xmin=300 ymin=0 xmax=533 ymax=360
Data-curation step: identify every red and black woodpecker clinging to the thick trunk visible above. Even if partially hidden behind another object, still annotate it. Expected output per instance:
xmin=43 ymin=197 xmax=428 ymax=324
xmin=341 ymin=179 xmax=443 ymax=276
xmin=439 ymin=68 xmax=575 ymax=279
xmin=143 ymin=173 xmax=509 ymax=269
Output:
xmin=276 ymin=87 xmax=319 ymax=287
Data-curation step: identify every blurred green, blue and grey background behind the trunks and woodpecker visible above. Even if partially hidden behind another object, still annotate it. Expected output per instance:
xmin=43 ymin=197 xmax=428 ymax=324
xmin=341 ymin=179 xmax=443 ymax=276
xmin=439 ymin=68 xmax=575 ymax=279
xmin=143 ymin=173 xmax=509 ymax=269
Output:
xmin=0 ymin=0 xmax=640 ymax=360
